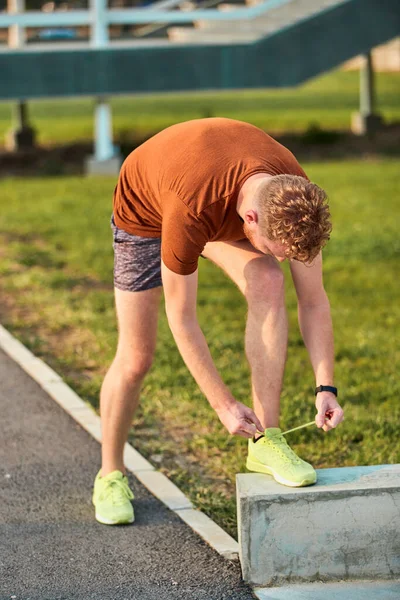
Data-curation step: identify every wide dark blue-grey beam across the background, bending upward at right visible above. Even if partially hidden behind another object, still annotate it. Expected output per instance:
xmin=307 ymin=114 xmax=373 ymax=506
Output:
xmin=0 ymin=0 xmax=400 ymax=100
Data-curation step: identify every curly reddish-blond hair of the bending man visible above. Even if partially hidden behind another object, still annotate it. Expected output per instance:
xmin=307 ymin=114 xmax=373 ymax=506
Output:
xmin=255 ymin=175 xmax=332 ymax=264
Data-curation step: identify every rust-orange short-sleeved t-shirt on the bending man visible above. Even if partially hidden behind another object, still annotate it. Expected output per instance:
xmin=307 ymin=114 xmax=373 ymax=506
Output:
xmin=113 ymin=118 xmax=306 ymax=275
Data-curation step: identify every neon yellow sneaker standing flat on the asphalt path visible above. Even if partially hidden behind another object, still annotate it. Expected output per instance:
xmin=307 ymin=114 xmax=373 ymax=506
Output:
xmin=92 ymin=470 xmax=135 ymax=525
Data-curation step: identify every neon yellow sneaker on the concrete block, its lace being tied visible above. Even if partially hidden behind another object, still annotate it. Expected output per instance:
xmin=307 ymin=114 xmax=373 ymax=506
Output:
xmin=246 ymin=427 xmax=317 ymax=487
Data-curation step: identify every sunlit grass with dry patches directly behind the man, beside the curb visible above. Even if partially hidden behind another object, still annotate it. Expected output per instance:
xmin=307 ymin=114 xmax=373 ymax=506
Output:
xmin=0 ymin=160 xmax=400 ymax=535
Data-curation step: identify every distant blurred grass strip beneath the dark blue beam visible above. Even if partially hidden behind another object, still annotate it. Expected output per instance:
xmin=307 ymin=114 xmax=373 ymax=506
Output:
xmin=0 ymin=71 xmax=400 ymax=144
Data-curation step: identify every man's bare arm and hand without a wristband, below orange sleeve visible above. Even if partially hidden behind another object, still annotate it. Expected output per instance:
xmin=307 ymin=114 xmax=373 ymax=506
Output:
xmin=161 ymin=262 xmax=262 ymax=437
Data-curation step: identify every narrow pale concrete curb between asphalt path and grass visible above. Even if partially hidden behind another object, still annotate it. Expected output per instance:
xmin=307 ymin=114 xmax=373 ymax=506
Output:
xmin=0 ymin=325 xmax=239 ymax=560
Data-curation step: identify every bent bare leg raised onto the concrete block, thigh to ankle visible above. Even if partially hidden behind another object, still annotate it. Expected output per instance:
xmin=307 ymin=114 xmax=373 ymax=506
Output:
xmin=203 ymin=240 xmax=288 ymax=428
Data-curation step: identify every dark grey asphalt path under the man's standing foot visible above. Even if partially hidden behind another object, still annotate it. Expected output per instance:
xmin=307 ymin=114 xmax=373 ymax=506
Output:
xmin=0 ymin=350 xmax=254 ymax=600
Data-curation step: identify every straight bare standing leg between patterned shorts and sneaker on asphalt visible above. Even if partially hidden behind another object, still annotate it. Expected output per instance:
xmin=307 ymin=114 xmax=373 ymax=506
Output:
xmin=100 ymin=287 xmax=162 ymax=477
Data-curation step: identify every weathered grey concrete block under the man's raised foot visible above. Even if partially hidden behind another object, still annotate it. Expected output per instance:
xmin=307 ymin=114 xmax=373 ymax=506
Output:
xmin=237 ymin=465 xmax=400 ymax=586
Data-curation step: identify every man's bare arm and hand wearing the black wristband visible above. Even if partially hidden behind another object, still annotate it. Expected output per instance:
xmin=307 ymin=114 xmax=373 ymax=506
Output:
xmin=290 ymin=254 xmax=343 ymax=431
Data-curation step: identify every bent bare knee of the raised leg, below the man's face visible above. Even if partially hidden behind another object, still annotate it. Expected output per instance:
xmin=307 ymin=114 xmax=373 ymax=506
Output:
xmin=245 ymin=257 xmax=285 ymax=309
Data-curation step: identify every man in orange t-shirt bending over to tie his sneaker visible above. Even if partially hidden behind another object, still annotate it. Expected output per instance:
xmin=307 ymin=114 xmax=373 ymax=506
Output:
xmin=93 ymin=118 xmax=343 ymax=524
